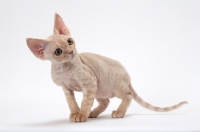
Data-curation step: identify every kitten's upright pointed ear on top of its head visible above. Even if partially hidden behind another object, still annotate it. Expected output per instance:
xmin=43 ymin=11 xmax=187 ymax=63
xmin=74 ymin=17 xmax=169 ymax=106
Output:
xmin=54 ymin=13 xmax=70 ymax=35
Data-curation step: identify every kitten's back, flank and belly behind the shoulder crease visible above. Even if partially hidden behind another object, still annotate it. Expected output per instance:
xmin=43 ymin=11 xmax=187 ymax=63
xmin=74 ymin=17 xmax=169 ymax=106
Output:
xmin=80 ymin=53 xmax=130 ymax=98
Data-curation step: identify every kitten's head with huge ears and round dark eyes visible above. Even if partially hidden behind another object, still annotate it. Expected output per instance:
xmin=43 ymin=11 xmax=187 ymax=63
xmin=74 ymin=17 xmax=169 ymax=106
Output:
xmin=26 ymin=14 xmax=76 ymax=63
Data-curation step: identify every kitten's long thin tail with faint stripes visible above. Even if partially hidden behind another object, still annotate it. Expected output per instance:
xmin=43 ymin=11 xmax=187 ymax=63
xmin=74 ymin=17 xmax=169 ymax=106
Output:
xmin=130 ymin=86 xmax=188 ymax=112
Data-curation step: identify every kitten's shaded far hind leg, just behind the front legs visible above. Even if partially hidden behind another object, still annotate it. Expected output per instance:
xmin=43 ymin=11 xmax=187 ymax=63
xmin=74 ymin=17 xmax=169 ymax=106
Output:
xmin=89 ymin=98 xmax=110 ymax=118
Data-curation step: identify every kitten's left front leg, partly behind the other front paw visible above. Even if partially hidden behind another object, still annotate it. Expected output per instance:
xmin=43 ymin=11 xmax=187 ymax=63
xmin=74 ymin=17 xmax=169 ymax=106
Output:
xmin=63 ymin=87 xmax=80 ymax=119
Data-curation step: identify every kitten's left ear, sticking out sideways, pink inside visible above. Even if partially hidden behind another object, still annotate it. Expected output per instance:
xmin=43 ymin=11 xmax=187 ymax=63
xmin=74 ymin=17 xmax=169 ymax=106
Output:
xmin=26 ymin=38 xmax=48 ymax=60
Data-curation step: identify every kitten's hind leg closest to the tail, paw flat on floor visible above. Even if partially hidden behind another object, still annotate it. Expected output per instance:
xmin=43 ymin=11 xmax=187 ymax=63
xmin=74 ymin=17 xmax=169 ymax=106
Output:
xmin=112 ymin=87 xmax=133 ymax=118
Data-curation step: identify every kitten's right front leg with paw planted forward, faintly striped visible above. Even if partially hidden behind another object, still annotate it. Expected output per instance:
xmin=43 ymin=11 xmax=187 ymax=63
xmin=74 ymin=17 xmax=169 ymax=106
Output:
xmin=71 ymin=83 xmax=97 ymax=122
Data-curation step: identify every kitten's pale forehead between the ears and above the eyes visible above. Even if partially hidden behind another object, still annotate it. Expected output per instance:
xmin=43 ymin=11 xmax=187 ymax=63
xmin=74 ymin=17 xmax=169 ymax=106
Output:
xmin=47 ymin=34 xmax=70 ymax=48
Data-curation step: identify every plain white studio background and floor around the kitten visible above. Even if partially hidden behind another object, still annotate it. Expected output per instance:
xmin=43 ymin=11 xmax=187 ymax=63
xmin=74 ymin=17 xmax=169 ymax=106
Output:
xmin=0 ymin=0 xmax=200 ymax=131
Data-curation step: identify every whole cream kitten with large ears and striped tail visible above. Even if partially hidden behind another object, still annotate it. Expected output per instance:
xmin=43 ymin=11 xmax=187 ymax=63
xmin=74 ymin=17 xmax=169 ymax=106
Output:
xmin=27 ymin=14 xmax=187 ymax=122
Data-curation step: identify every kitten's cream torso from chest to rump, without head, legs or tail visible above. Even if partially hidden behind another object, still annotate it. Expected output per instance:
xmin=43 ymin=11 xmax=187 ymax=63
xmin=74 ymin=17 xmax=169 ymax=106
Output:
xmin=51 ymin=53 xmax=130 ymax=98
